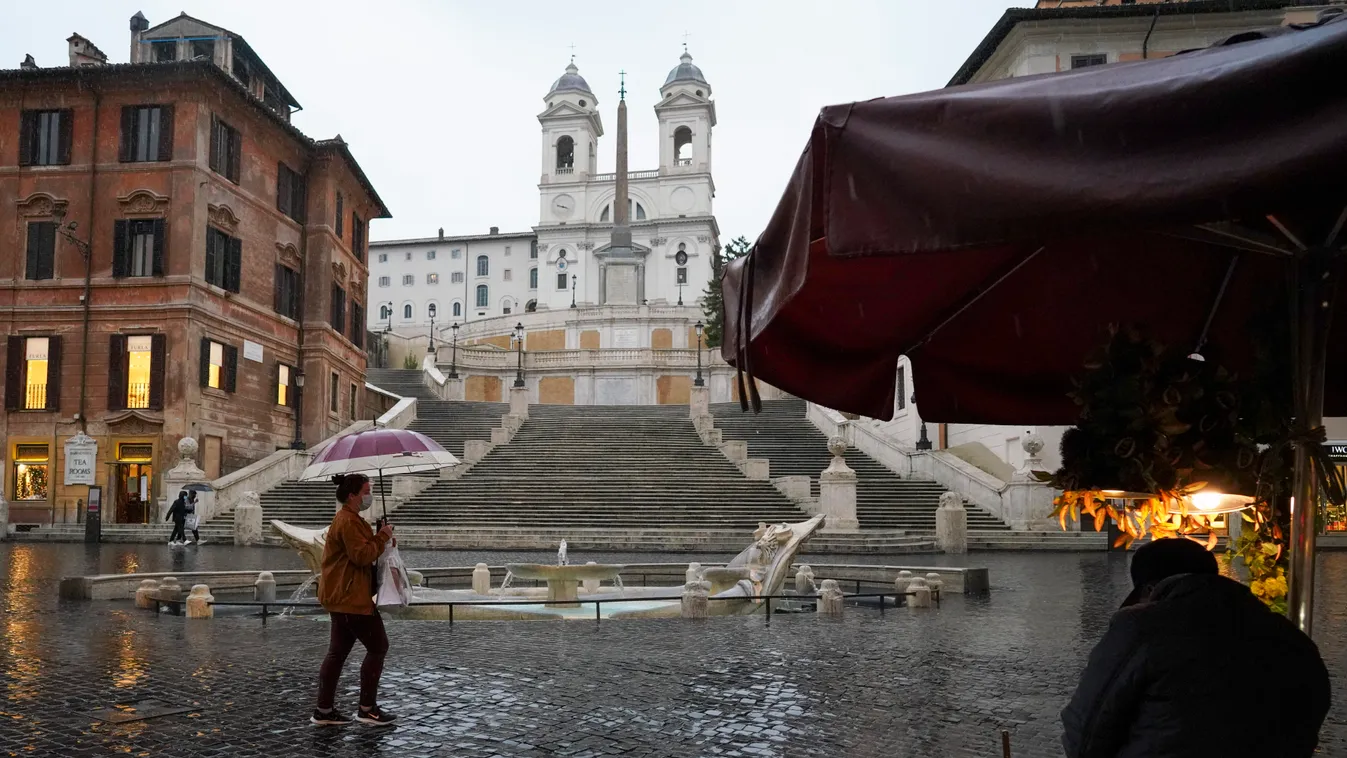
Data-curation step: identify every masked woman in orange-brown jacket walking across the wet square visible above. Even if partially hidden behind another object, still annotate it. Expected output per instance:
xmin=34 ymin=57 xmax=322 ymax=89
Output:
xmin=310 ymin=474 xmax=396 ymax=726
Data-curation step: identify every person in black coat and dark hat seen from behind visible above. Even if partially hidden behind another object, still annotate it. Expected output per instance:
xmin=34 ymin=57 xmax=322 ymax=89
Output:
xmin=1061 ymin=539 xmax=1331 ymax=758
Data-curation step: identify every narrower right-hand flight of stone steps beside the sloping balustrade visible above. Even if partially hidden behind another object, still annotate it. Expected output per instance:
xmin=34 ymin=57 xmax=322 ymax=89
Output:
xmin=711 ymin=399 xmax=1009 ymax=532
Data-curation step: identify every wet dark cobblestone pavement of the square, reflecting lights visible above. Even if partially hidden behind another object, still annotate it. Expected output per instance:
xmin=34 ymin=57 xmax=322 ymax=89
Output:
xmin=0 ymin=545 xmax=1347 ymax=758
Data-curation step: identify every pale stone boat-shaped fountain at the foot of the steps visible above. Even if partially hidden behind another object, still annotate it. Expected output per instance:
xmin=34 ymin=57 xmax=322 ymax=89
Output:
xmin=271 ymin=516 xmax=823 ymax=621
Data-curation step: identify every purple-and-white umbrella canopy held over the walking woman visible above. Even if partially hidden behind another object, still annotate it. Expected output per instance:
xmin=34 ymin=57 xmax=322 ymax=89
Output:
xmin=299 ymin=429 xmax=458 ymax=482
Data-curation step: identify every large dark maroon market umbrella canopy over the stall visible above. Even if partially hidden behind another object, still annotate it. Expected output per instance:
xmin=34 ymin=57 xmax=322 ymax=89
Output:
xmin=722 ymin=18 xmax=1347 ymax=424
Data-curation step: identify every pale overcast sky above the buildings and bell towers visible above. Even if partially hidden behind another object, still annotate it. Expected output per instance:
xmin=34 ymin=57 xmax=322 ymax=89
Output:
xmin=0 ymin=0 xmax=1032 ymax=241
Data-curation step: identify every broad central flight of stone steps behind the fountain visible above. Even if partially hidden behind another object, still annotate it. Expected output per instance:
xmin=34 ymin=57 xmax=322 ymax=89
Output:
xmin=396 ymin=405 xmax=806 ymax=535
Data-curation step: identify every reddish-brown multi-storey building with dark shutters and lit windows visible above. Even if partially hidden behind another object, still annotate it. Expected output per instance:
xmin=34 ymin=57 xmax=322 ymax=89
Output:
xmin=0 ymin=13 xmax=388 ymax=524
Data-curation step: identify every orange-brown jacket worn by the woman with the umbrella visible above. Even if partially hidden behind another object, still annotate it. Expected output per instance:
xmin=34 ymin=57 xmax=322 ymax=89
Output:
xmin=318 ymin=508 xmax=387 ymax=615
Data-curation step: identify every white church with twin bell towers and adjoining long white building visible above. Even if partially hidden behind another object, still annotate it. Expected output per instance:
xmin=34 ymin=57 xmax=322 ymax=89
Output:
xmin=368 ymin=53 xmax=719 ymax=329
